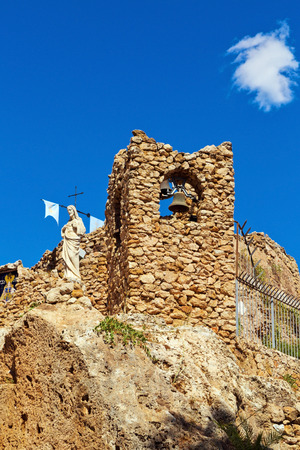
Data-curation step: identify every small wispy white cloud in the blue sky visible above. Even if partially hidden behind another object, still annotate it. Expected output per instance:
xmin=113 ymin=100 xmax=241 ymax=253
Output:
xmin=227 ymin=22 xmax=299 ymax=111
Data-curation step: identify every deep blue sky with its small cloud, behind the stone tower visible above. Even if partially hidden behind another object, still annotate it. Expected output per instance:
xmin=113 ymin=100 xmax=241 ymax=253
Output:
xmin=0 ymin=0 xmax=300 ymax=266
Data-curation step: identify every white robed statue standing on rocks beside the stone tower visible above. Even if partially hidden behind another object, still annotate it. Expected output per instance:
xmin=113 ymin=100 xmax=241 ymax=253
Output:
xmin=61 ymin=205 xmax=85 ymax=281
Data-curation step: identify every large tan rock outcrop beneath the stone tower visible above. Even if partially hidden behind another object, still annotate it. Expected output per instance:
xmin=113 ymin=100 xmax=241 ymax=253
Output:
xmin=0 ymin=303 xmax=300 ymax=450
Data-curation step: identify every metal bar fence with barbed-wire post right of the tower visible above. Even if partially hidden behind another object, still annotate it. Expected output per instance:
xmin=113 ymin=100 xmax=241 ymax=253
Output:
xmin=236 ymin=223 xmax=300 ymax=358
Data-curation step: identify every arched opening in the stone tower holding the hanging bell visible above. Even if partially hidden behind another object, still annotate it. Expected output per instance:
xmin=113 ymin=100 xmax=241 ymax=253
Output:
xmin=160 ymin=170 xmax=202 ymax=222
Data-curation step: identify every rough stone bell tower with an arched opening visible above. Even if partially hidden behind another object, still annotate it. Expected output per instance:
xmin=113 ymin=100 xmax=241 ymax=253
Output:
xmin=106 ymin=130 xmax=235 ymax=342
